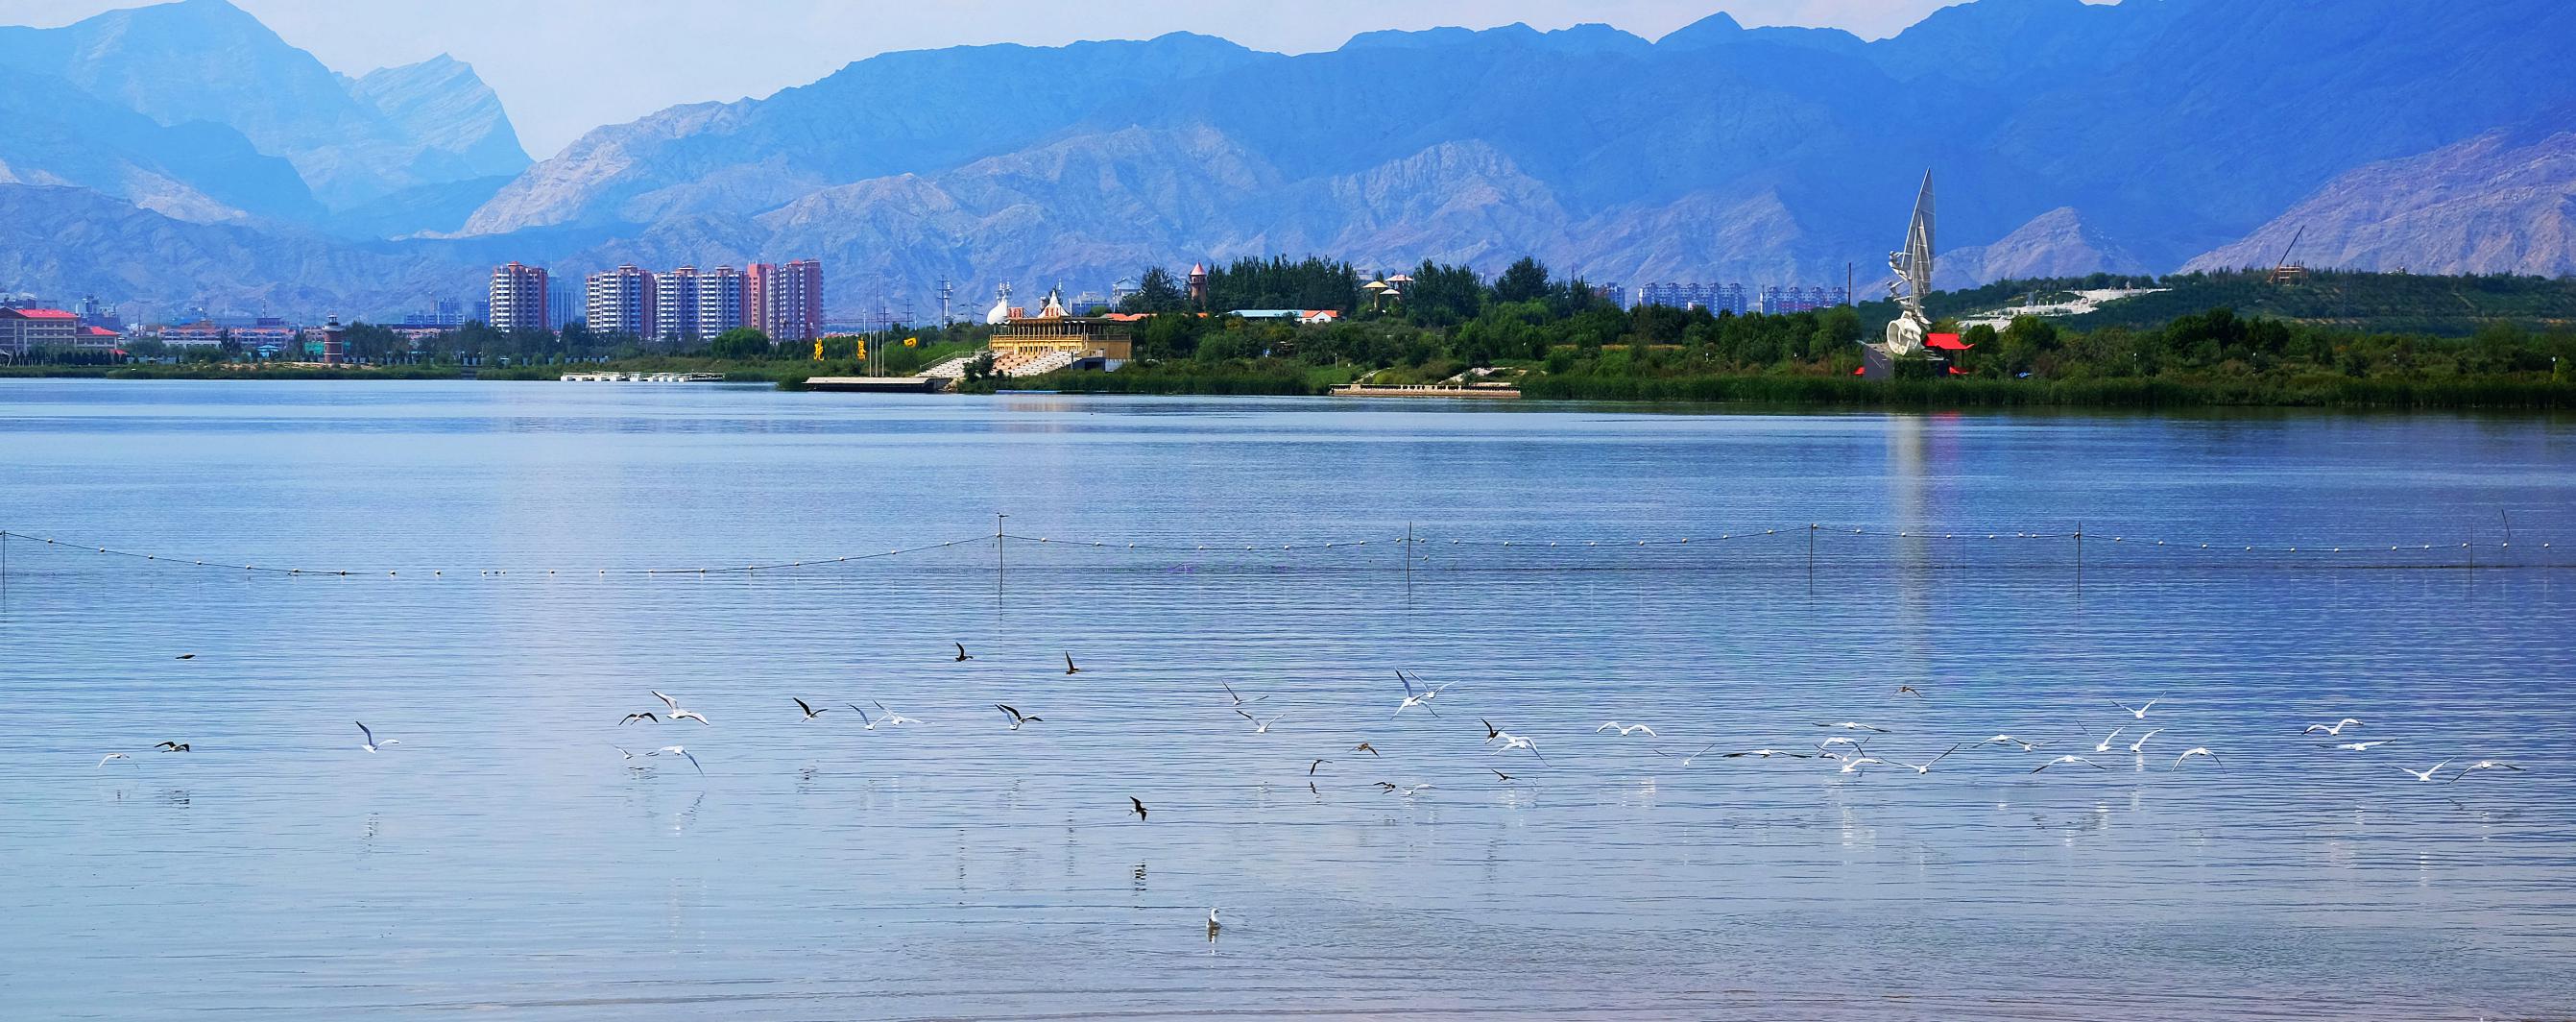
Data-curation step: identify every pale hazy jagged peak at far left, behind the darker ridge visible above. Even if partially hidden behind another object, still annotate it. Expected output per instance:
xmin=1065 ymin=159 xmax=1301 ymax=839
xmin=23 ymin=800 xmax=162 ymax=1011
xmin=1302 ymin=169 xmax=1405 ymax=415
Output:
xmin=0 ymin=0 xmax=525 ymax=208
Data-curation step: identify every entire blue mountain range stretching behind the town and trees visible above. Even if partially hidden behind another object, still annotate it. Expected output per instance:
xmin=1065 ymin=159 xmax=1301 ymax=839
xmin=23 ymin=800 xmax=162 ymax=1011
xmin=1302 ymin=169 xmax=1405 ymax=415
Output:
xmin=0 ymin=0 xmax=2576 ymax=314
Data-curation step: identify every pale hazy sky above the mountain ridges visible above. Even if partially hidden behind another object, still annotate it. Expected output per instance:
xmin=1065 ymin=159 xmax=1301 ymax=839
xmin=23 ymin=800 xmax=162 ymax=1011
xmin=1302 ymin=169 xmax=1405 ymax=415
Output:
xmin=0 ymin=0 xmax=1988 ymax=159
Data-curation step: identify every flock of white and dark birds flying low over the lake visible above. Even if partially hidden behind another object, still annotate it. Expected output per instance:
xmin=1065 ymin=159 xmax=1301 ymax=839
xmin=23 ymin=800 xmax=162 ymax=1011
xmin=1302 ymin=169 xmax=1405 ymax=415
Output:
xmin=98 ymin=644 xmax=2522 ymax=797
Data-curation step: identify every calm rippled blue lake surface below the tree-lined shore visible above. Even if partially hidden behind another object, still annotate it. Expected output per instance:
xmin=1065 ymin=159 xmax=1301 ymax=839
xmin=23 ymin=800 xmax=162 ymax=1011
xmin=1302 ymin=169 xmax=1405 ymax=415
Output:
xmin=0 ymin=381 xmax=2576 ymax=1019
